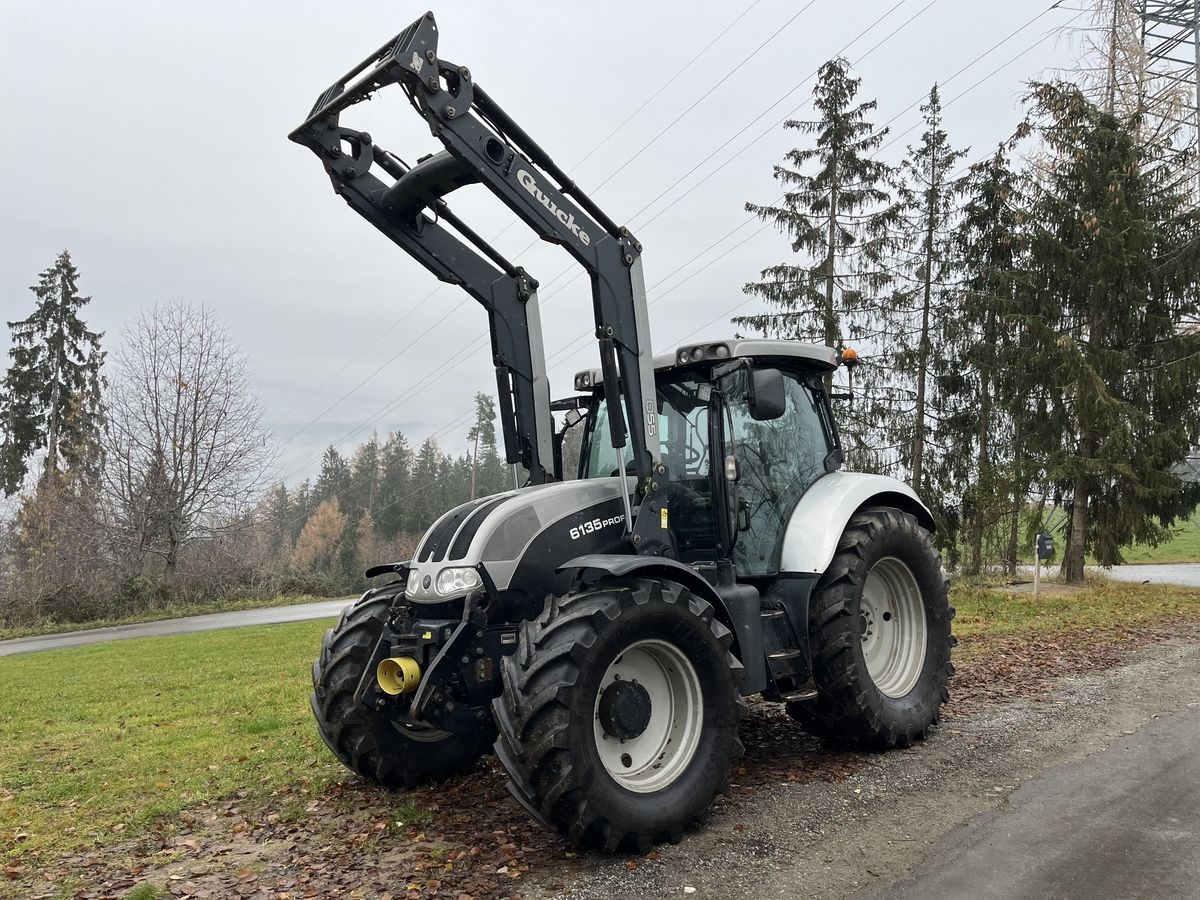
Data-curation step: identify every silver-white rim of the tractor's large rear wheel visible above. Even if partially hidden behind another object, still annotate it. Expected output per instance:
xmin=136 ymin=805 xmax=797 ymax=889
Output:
xmin=859 ymin=557 xmax=926 ymax=697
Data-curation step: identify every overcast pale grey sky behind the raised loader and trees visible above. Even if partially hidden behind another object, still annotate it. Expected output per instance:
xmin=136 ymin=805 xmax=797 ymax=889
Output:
xmin=0 ymin=0 xmax=1086 ymax=484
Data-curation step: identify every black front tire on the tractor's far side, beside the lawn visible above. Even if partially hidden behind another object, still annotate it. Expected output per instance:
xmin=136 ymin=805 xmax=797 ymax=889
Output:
xmin=311 ymin=588 xmax=494 ymax=787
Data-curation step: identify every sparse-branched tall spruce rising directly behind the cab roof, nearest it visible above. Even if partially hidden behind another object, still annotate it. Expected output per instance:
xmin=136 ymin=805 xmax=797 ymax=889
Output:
xmin=734 ymin=58 xmax=895 ymax=347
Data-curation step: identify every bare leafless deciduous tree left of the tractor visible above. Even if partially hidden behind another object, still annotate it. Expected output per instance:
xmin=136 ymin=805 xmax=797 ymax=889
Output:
xmin=106 ymin=301 xmax=272 ymax=581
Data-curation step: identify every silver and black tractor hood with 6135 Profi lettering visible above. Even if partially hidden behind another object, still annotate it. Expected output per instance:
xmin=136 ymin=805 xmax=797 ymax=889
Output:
xmin=406 ymin=478 xmax=634 ymax=604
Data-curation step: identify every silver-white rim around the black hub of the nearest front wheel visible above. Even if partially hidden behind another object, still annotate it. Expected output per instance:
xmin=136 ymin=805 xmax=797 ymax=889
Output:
xmin=594 ymin=640 xmax=704 ymax=793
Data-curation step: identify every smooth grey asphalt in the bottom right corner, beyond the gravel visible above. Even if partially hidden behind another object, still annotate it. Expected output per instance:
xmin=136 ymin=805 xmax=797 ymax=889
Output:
xmin=880 ymin=710 xmax=1200 ymax=900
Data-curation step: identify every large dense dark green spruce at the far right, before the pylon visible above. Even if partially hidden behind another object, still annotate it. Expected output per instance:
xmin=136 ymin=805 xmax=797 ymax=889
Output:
xmin=1022 ymin=84 xmax=1200 ymax=582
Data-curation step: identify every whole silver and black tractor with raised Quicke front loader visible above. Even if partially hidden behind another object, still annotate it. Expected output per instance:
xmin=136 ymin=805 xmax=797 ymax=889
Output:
xmin=290 ymin=13 xmax=953 ymax=850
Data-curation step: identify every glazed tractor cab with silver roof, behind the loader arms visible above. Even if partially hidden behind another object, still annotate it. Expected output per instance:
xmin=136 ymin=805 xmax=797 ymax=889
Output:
xmin=568 ymin=340 xmax=842 ymax=578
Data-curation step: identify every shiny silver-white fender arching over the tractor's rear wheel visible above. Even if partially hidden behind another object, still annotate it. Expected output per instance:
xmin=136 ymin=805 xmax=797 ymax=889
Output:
xmin=780 ymin=472 xmax=935 ymax=575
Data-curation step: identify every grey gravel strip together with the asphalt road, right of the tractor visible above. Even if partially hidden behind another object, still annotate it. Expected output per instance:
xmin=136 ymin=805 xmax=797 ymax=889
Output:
xmin=526 ymin=640 xmax=1200 ymax=900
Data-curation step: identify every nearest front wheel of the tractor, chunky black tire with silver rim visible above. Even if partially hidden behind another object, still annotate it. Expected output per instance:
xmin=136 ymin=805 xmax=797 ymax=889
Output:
xmin=493 ymin=578 xmax=742 ymax=852
